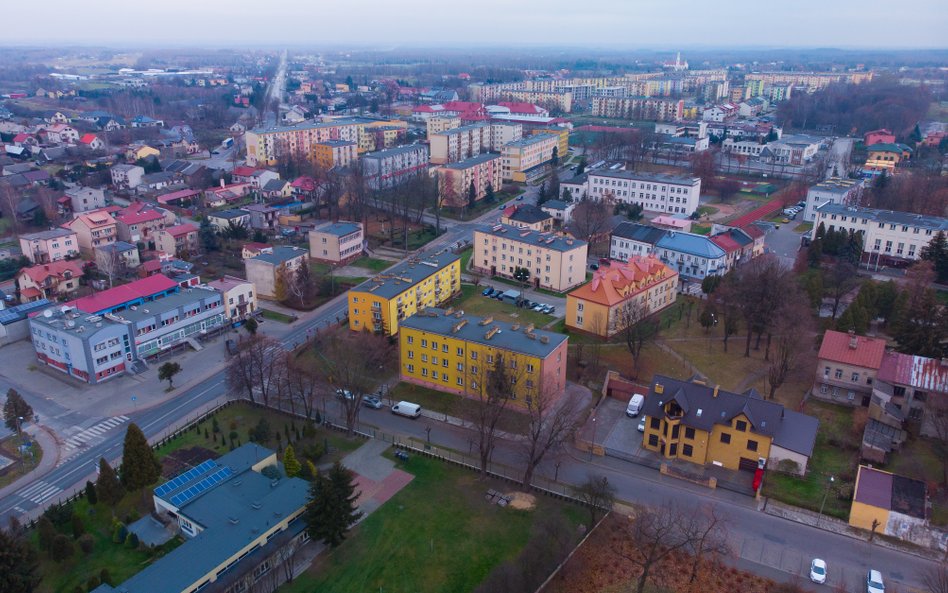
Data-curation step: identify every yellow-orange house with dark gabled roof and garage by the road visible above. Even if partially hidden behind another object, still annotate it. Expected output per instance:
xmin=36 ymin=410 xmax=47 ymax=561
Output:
xmin=642 ymin=375 xmax=819 ymax=475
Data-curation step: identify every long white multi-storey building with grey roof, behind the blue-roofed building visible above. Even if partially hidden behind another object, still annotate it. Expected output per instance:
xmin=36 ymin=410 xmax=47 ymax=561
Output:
xmin=574 ymin=171 xmax=701 ymax=216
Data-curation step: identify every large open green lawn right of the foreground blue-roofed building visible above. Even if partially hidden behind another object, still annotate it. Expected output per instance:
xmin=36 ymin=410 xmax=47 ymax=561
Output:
xmin=280 ymin=455 xmax=586 ymax=593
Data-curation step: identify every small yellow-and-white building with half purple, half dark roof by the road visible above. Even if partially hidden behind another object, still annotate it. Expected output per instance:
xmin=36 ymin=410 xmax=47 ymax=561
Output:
xmin=849 ymin=465 xmax=930 ymax=541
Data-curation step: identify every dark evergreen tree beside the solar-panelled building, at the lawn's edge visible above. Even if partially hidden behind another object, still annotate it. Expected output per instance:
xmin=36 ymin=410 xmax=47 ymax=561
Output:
xmin=306 ymin=461 xmax=362 ymax=548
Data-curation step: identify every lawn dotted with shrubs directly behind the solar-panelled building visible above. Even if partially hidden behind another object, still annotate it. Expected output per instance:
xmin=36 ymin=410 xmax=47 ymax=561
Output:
xmin=156 ymin=402 xmax=362 ymax=465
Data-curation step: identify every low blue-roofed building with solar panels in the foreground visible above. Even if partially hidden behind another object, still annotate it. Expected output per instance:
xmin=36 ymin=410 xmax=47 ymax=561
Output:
xmin=95 ymin=443 xmax=309 ymax=593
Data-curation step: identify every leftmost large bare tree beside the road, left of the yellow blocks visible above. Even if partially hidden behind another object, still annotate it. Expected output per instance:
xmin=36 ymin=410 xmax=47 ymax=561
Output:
xmin=227 ymin=334 xmax=285 ymax=406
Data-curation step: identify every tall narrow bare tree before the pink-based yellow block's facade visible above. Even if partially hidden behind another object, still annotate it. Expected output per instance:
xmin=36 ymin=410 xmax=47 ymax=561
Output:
xmin=474 ymin=355 xmax=520 ymax=476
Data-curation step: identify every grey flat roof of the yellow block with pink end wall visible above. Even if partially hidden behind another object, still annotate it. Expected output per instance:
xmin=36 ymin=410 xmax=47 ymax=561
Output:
xmin=399 ymin=308 xmax=567 ymax=358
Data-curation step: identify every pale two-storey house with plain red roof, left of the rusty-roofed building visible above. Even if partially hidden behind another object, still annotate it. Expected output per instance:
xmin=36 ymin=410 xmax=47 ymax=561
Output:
xmin=812 ymin=330 xmax=885 ymax=406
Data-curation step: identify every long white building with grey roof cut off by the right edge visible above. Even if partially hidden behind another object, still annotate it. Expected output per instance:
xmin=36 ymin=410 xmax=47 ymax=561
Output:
xmin=810 ymin=203 xmax=948 ymax=266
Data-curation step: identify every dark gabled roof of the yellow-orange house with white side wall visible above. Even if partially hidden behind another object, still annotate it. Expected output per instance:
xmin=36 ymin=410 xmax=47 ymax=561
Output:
xmin=643 ymin=375 xmax=820 ymax=457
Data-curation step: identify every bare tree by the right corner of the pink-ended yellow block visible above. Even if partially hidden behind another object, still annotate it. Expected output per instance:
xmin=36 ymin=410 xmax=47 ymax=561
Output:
xmin=521 ymin=382 xmax=580 ymax=488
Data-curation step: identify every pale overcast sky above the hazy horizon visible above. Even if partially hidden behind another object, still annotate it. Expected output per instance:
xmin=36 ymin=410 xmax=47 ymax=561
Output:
xmin=0 ymin=0 xmax=948 ymax=49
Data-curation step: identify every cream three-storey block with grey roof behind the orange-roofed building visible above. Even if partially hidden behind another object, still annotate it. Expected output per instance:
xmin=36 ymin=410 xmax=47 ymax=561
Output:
xmin=471 ymin=224 xmax=588 ymax=292
